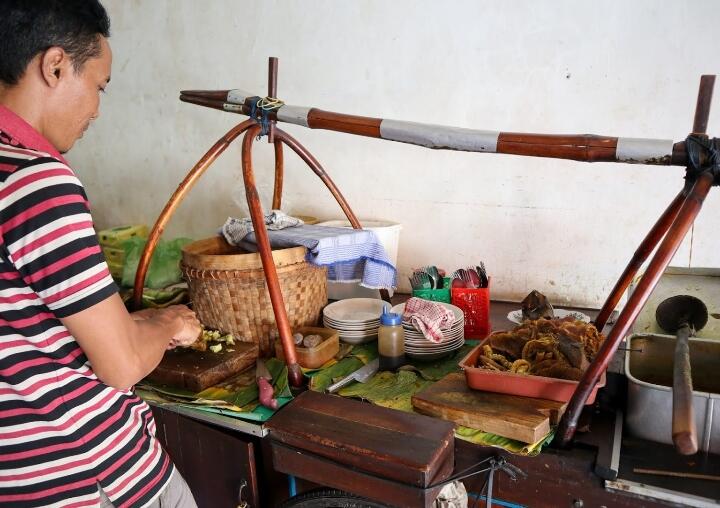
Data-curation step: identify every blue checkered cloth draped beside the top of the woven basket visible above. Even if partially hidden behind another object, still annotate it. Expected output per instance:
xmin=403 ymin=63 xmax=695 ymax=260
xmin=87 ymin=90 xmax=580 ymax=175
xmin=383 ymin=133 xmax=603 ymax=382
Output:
xmin=226 ymin=224 xmax=397 ymax=289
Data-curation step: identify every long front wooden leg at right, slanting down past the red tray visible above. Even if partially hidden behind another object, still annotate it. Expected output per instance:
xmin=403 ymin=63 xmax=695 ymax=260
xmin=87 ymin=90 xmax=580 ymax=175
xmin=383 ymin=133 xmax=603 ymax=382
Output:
xmin=556 ymin=172 xmax=713 ymax=446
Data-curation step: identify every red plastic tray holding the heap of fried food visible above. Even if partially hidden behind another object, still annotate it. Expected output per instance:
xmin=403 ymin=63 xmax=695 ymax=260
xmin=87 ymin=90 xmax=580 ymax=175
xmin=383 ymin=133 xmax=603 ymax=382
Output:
xmin=459 ymin=341 xmax=605 ymax=404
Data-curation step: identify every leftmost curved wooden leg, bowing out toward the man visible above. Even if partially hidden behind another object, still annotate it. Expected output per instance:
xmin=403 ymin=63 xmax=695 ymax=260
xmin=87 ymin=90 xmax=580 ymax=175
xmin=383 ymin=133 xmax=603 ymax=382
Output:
xmin=133 ymin=120 xmax=256 ymax=310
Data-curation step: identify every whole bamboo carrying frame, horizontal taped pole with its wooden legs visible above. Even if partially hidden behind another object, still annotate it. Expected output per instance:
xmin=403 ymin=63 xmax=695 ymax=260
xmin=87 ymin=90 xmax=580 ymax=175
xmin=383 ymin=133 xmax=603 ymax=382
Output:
xmin=134 ymin=58 xmax=717 ymax=418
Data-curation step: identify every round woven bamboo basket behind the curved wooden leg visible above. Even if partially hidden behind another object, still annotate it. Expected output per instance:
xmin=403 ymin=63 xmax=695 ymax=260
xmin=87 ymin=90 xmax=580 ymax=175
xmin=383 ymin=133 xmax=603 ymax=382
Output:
xmin=180 ymin=236 xmax=327 ymax=356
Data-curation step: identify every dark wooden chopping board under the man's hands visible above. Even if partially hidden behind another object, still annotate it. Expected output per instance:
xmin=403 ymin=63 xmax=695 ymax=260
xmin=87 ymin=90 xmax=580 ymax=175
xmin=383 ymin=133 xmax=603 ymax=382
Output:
xmin=147 ymin=342 xmax=258 ymax=393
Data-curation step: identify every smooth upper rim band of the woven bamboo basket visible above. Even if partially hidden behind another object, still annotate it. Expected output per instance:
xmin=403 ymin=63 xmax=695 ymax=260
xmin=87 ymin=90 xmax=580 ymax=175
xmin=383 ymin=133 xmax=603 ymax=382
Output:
xmin=182 ymin=236 xmax=307 ymax=270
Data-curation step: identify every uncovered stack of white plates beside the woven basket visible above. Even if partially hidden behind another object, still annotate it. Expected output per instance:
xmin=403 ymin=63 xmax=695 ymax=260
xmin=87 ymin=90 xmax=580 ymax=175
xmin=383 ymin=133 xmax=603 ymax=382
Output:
xmin=323 ymin=298 xmax=385 ymax=344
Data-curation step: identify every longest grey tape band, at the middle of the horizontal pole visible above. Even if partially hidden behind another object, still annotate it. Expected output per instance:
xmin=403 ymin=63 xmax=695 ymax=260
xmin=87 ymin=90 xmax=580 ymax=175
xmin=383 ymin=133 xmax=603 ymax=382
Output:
xmin=380 ymin=120 xmax=500 ymax=153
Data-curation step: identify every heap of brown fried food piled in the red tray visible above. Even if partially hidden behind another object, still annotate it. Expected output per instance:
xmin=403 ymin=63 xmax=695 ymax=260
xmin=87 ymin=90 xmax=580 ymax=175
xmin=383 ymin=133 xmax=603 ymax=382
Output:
xmin=477 ymin=317 xmax=605 ymax=381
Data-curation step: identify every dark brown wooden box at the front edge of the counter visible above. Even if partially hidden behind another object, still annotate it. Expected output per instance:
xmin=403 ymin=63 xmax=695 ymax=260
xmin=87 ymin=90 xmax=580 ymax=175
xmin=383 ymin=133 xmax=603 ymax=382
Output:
xmin=266 ymin=391 xmax=455 ymax=487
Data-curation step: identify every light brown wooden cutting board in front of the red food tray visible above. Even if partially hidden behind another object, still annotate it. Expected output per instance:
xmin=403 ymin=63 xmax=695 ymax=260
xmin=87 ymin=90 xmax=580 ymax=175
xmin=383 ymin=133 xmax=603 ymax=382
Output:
xmin=412 ymin=373 xmax=567 ymax=443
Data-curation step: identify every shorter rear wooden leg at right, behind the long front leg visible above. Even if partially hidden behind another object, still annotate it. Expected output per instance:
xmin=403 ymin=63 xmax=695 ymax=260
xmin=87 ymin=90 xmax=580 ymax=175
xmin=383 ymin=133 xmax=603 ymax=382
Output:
xmin=595 ymin=185 xmax=690 ymax=331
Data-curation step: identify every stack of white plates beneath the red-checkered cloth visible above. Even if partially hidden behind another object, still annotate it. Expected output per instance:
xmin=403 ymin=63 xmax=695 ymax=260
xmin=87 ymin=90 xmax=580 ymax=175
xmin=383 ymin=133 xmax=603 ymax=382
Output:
xmin=391 ymin=302 xmax=465 ymax=360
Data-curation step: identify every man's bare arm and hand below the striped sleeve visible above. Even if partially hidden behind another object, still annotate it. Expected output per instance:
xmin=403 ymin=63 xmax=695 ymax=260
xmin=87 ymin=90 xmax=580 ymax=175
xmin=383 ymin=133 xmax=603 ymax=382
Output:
xmin=60 ymin=293 xmax=201 ymax=390
